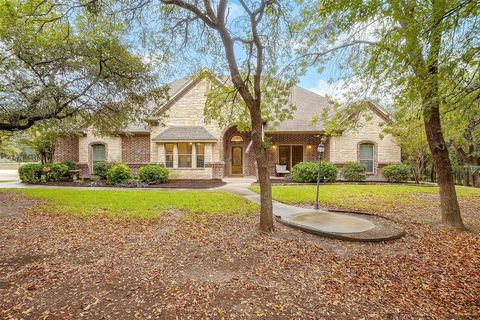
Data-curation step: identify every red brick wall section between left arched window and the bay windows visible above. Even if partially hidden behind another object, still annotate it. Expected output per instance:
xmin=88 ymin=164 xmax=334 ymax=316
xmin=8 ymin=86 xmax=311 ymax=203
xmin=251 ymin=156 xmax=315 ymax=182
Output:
xmin=122 ymin=135 xmax=150 ymax=164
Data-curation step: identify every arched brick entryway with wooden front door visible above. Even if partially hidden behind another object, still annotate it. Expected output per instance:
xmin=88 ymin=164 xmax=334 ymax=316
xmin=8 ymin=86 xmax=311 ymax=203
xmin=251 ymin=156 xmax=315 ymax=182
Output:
xmin=222 ymin=126 xmax=256 ymax=176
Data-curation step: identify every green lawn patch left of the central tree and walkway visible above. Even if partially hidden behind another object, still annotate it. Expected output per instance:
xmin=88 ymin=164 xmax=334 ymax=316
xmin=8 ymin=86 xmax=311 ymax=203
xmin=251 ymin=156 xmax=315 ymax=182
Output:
xmin=2 ymin=189 xmax=258 ymax=219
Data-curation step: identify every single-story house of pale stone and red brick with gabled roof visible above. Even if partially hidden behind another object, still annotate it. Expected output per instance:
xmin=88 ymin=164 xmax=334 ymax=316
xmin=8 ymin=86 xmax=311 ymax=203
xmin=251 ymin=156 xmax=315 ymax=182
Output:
xmin=54 ymin=76 xmax=400 ymax=179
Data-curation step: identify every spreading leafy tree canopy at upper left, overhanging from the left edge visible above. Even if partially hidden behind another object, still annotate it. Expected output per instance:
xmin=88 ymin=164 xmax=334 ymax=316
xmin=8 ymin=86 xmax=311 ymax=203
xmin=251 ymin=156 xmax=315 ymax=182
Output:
xmin=0 ymin=0 xmax=163 ymax=131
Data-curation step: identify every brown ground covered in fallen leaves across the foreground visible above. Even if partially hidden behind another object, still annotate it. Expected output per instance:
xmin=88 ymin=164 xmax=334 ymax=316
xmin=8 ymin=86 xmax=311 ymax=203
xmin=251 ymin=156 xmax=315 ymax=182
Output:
xmin=0 ymin=186 xmax=480 ymax=319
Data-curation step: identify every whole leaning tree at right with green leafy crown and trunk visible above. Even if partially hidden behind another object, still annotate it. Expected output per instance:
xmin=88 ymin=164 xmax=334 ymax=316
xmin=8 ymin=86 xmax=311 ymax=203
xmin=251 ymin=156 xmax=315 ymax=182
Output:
xmin=303 ymin=0 xmax=480 ymax=229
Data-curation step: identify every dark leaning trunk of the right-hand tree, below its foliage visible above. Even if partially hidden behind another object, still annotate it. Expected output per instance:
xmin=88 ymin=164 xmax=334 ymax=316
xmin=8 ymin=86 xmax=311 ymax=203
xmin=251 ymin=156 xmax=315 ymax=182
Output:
xmin=423 ymin=106 xmax=464 ymax=229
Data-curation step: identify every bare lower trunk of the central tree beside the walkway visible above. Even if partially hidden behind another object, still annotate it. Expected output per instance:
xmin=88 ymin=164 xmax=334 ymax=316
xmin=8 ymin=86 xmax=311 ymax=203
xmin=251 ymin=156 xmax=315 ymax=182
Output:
xmin=250 ymin=110 xmax=275 ymax=232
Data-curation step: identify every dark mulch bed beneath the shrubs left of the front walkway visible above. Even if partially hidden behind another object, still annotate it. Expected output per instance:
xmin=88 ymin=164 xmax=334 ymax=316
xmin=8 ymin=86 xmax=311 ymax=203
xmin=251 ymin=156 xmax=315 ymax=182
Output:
xmin=33 ymin=179 xmax=225 ymax=189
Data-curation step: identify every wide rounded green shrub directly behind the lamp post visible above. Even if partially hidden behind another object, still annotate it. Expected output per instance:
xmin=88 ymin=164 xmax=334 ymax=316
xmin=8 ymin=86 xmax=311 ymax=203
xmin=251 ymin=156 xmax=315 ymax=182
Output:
xmin=292 ymin=161 xmax=337 ymax=182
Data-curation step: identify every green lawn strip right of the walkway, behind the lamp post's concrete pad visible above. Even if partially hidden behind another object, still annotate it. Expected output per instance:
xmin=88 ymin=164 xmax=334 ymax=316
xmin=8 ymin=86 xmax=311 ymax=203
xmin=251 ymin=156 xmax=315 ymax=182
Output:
xmin=250 ymin=184 xmax=480 ymax=210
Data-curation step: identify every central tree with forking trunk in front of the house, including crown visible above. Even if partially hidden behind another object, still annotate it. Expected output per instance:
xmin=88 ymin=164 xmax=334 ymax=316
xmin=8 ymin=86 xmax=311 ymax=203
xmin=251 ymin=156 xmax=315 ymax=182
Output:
xmin=125 ymin=0 xmax=293 ymax=232
